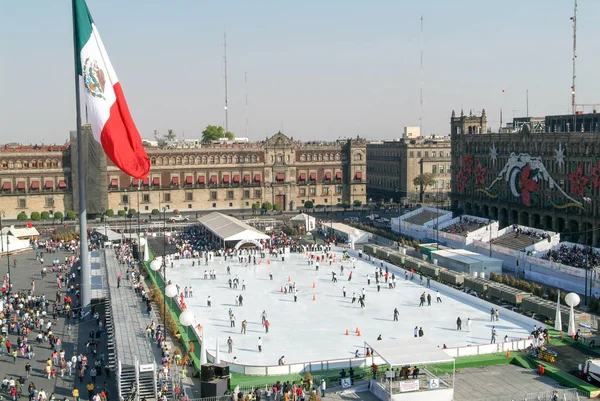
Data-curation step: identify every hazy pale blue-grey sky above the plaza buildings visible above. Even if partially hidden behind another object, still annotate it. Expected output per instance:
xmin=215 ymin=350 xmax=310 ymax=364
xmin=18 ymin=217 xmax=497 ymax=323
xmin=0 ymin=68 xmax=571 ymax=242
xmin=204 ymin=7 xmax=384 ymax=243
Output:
xmin=0 ymin=0 xmax=600 ymax=143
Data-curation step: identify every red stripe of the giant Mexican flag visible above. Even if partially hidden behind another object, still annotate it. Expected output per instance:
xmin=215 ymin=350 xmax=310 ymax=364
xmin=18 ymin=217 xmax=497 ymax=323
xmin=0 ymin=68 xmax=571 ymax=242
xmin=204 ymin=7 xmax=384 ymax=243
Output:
xmin=100 ymin=82 xmax=150 ymax=179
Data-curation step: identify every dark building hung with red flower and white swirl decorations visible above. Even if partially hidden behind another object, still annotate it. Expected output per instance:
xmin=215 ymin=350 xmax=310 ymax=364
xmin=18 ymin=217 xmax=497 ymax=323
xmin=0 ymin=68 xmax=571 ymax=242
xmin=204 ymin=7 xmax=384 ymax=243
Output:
xmin=450 ymin=112 xmax=600 ymax=246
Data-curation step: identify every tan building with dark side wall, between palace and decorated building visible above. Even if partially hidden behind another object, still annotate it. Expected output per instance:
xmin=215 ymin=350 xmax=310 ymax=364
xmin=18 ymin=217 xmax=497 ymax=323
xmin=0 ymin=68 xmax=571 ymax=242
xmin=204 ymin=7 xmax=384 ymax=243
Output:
xmin=367 ymin=137 xmax=450 ymax=202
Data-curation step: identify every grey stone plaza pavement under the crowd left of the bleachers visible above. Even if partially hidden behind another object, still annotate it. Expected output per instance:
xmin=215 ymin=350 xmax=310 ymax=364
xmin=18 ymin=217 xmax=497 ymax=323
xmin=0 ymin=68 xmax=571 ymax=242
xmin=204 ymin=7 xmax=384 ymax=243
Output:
xmin=0 ymin=250 xmax=117 ymax=400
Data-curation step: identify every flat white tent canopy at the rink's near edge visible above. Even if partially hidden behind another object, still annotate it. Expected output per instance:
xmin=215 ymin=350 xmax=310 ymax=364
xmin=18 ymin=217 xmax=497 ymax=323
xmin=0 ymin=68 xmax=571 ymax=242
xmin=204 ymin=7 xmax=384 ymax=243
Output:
xmin=365 ymin=338 xmax=454 ymax=366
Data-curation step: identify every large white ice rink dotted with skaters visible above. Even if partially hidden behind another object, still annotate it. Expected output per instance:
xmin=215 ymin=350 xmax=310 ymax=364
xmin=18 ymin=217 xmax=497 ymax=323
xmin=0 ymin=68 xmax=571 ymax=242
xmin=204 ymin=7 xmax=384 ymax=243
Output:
xmin=167 ymin=248 xmax=530 ymax=365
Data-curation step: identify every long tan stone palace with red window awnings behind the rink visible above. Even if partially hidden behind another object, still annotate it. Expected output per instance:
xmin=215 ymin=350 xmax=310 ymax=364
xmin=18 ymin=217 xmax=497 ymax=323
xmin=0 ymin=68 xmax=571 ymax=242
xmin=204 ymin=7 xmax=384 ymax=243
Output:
xmin=0 ymin=129 xmax=367 ymax=218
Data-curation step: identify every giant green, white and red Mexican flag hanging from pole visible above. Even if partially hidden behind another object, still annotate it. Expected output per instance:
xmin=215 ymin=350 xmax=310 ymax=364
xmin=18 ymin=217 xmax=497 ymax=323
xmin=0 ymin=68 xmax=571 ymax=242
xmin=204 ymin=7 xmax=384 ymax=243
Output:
xmin=73 ymin=0 xmax=150 ymax=178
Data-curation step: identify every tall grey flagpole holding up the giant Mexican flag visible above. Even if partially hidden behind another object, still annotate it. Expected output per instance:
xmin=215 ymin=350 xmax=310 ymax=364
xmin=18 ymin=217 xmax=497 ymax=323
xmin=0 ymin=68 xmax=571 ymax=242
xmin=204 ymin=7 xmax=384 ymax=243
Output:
xmin=71 ymin=0 xmax=91 ymax=314
